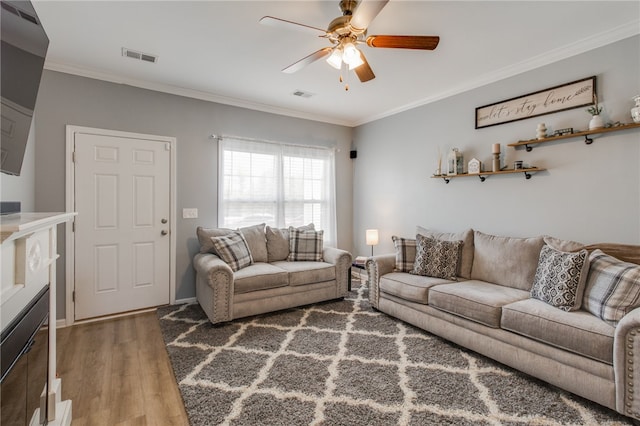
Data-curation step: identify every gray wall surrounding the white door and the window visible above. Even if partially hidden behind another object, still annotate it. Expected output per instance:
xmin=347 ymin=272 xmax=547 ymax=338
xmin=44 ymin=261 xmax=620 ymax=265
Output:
xmin=35 ymin=71 xmax=353 ymax=317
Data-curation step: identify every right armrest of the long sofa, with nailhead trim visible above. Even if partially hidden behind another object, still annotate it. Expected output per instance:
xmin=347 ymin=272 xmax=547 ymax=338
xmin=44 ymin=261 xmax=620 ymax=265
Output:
xmin=613 ymin=308 xmax=640 ymax=418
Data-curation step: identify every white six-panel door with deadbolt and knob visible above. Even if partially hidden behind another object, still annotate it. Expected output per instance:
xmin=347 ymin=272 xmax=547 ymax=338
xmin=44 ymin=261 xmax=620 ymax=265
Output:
xmin=74 ymin=133 xmax=172 ymax=320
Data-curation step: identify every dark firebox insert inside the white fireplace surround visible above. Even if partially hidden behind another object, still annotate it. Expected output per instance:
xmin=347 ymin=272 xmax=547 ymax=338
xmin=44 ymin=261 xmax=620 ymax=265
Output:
xmin=0 ymin=285 xmax=49 ymax=426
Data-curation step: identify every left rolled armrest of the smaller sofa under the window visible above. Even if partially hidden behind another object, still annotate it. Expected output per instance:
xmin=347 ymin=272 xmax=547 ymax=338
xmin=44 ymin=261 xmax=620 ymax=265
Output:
xmin=193 ymin=253 xmax=238 ymax=324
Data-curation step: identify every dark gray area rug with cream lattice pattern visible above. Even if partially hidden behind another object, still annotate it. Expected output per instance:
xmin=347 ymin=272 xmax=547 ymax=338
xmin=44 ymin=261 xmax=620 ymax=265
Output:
xmin=158 ymin=283 xmax=632 ymax=426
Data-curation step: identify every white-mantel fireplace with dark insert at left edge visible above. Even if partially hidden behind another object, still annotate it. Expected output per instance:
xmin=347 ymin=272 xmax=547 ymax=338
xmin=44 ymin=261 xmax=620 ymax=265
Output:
xmin=0 ymin=211 xmax=76 ymax=426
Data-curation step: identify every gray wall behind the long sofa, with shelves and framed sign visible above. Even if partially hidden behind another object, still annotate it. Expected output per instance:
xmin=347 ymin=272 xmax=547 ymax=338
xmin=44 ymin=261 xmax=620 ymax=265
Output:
xmin=354 ymin=36 xmax=640 ymax=255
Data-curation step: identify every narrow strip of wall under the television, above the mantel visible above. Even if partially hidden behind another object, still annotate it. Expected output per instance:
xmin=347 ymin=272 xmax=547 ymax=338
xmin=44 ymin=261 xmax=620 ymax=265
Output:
xmin=0 ymin=116 xmax=36 ymax=212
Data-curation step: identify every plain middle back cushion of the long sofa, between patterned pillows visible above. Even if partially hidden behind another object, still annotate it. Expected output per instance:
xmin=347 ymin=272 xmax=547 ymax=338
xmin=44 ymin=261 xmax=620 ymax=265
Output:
xmin=471 ymin=231 xmax=544 ymax=291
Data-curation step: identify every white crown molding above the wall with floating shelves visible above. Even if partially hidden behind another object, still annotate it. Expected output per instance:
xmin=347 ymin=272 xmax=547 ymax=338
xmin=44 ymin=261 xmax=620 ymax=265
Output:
xmin=353 ymin=19 xmax=640 ymax=127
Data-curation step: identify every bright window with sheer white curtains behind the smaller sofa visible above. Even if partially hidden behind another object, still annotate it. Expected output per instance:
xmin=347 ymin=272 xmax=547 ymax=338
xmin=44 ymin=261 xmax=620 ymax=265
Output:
xmin=218 ymin=138 xmax=336 ymax=246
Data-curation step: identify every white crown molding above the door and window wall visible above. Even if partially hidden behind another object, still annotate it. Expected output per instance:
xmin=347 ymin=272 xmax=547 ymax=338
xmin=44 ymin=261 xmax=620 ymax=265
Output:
xmin=44 ymin=61 xmax=353 ymax=127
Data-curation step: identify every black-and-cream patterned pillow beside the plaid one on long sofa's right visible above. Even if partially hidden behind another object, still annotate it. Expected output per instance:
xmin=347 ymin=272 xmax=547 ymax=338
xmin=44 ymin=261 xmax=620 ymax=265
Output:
xmin=531 ymin=245 xmax=589 ymax=312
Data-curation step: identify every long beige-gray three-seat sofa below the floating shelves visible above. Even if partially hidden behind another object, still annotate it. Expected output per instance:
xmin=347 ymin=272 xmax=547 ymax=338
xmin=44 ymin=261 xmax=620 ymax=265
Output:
xmin=366 ymin=228 xmax=640 ymax=419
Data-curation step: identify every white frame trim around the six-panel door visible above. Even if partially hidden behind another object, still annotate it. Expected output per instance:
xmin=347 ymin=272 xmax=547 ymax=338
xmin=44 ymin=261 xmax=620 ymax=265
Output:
xmin=65 ymin=125 xmax=176 ymax=327
